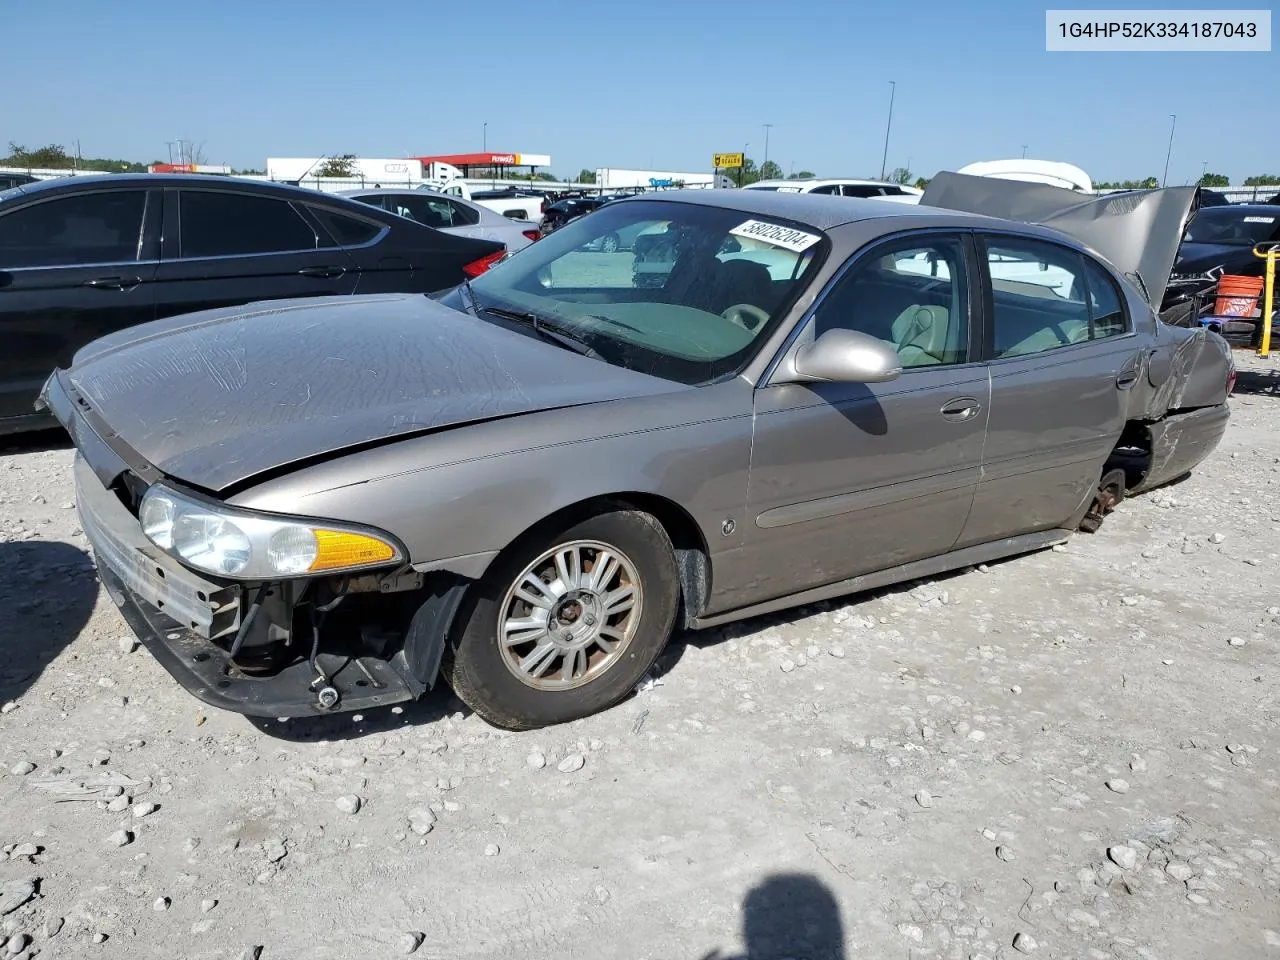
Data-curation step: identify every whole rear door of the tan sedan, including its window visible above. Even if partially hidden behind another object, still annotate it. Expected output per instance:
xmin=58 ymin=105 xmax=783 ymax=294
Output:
xmin=959 ymin=233 xmax=1142 ymax=547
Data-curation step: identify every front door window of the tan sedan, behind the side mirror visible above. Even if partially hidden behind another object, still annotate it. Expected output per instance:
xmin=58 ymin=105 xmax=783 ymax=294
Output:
xmin=813 ymin=236 xmax=969 ymax=369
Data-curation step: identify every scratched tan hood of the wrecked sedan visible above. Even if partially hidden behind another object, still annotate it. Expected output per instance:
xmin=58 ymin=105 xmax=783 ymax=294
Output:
xmin=63 ymin=294 xmax=678 ymax=492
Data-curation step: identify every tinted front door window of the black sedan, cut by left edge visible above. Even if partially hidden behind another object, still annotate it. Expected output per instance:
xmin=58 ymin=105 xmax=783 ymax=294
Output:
xmin=0 ymin=189 xmax=147 ymax=269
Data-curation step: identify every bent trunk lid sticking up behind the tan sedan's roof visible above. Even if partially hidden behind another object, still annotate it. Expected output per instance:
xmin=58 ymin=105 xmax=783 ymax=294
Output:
xmin=920 ymin=172 xmax=1197 ymax=307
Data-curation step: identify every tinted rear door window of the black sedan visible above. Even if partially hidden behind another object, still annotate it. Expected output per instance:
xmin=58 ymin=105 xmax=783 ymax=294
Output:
xmin=179 ymin=191 xmax=316 ymax=257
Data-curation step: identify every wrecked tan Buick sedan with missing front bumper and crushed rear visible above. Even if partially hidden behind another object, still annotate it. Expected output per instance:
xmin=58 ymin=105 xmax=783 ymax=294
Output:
xmin=41 ymin=178 xmax=1234 ymax=728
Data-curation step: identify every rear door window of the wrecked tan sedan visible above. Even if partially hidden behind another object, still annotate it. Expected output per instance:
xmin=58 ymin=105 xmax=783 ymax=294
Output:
xmin=984 ymin=237 xmax=1125 ymax=358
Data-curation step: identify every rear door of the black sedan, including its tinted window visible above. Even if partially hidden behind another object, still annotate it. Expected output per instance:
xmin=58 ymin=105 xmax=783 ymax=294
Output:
xmin=156 ymin=187 xmax=360 ymax=323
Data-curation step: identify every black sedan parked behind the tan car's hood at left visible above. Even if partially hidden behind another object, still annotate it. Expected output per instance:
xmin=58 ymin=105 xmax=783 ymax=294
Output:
xmin=0 ymin=174 xmax=506 ymax=434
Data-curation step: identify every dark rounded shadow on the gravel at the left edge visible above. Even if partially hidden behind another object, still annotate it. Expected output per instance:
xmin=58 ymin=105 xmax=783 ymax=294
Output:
xmin=0 ymin=540 xmax=99 ymax=703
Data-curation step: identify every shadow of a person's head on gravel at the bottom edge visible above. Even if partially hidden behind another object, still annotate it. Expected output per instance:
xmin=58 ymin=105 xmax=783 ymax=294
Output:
xmin=699 ymin=873 xmax=845 ymax=960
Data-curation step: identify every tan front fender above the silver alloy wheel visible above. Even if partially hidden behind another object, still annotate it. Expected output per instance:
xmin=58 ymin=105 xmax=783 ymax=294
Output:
xmin=230 ymin=379 xmax=751 ymax=586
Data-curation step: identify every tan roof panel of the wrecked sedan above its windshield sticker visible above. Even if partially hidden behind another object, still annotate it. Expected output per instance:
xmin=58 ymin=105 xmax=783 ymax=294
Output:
xmin=613 ymin=188 xmax=962 ymax=230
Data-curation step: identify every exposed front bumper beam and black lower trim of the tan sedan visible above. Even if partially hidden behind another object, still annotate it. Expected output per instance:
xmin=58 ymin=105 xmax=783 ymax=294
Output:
xmin=74 ymin=456 xmax=425 ymax=717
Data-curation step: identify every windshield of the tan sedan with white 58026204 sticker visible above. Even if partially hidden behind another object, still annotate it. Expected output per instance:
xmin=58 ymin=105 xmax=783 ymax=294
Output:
xmin=471 ymin=200 xmax=829 ymax=384
